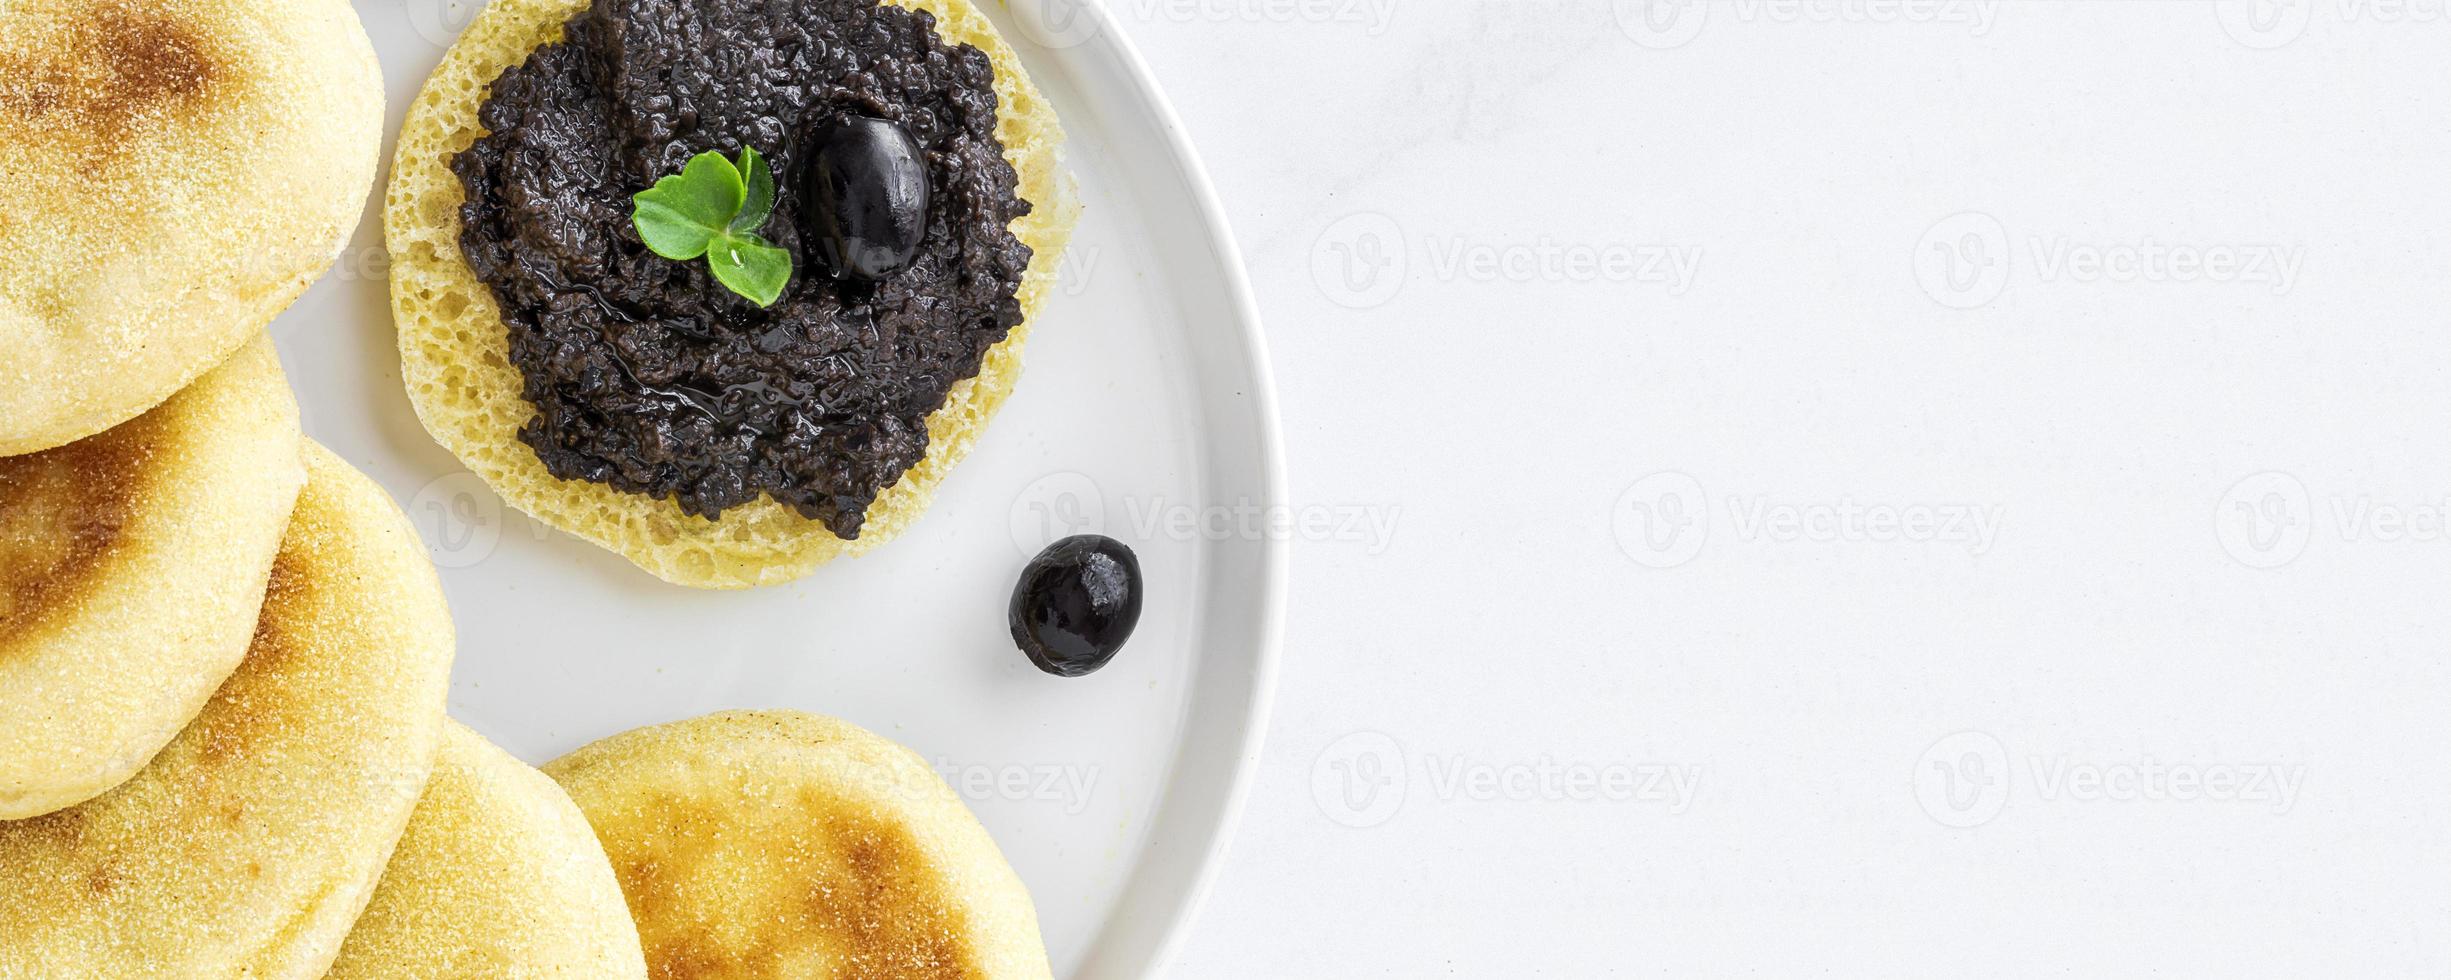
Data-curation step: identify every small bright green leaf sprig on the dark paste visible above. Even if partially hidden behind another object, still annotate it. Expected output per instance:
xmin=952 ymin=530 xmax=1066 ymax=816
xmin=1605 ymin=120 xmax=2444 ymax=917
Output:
xmin=630 ymin=147 xmax=792 ymax=306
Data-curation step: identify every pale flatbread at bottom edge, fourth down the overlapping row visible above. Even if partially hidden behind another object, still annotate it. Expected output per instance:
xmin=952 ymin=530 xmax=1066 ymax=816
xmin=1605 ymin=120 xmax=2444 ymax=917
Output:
xmin=326 ymin=723 xmax=647 ymax=980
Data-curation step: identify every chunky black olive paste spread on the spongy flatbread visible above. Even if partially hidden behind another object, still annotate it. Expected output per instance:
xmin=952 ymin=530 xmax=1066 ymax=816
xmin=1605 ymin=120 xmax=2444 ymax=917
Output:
xmin=451 ymin=0 xmax=1029 ymax=537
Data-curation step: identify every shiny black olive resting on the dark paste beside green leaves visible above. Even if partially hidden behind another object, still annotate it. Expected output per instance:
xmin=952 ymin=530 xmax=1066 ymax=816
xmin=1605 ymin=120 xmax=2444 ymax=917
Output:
xmin=801 ymin=115 xmax=929 ymax=282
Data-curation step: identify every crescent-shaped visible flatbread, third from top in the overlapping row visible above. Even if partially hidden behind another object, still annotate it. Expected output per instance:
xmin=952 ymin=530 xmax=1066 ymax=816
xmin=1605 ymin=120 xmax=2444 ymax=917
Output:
xmin=0 ymin=446 xmax=451 ymax=980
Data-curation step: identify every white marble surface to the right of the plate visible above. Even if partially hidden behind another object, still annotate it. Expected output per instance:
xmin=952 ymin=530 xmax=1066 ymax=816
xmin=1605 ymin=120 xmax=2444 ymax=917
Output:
xmin=1105 ymin=0 xmax=2451 ymax=978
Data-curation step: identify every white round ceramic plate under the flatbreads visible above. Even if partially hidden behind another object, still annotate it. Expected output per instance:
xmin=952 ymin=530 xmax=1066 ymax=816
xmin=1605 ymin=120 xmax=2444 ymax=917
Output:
xmin=275 ymin=0 xmax=1284 ymax=978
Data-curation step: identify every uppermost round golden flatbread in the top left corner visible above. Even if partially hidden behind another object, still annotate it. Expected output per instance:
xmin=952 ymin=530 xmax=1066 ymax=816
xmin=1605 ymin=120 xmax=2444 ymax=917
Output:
xmin=0 ymin=0 xmax=382 ymax=456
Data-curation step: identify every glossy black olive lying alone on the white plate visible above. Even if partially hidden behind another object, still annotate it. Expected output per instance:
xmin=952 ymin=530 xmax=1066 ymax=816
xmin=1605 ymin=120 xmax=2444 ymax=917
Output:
xmin=1012 ymin=534 xmax=1140 ymax=676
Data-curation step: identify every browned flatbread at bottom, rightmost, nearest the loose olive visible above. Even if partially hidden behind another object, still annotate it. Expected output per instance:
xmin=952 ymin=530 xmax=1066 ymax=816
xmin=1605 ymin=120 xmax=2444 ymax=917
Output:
xmin=544 ymin=711 xmax=1051 ymax=980
